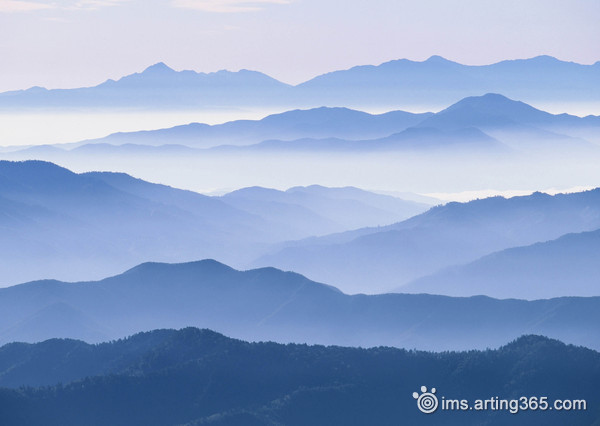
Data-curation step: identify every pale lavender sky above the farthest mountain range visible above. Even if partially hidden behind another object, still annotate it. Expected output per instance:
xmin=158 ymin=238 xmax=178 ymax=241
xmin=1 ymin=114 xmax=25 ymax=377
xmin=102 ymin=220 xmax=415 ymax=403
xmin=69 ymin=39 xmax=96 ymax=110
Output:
xmin=0 ymin=0 xmax=600 ymax=91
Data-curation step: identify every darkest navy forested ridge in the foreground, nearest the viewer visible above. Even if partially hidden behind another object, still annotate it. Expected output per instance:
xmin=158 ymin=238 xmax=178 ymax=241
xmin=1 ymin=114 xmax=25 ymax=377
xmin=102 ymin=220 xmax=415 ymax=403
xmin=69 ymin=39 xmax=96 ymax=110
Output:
xmin=0 ymin=328 xmax=600 ymax=426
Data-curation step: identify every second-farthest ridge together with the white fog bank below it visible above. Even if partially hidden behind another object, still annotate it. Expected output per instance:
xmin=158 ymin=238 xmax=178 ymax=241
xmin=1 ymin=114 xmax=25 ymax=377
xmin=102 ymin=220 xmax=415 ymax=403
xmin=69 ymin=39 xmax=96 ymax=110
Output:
xmin=0 ymin=94 xmax=600 ymax=197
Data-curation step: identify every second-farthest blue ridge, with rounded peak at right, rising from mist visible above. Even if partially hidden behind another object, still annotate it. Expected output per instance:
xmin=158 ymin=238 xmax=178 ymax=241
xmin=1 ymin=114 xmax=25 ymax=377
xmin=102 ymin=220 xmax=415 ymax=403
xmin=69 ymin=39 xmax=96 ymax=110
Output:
xmin=5 ymin=93 xmax=600 ymax=158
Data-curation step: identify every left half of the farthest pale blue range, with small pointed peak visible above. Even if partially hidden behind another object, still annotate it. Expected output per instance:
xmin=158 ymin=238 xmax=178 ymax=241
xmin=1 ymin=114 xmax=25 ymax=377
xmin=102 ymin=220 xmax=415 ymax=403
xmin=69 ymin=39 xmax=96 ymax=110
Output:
xmin=0 ymin=63 xmax=291 ymax=110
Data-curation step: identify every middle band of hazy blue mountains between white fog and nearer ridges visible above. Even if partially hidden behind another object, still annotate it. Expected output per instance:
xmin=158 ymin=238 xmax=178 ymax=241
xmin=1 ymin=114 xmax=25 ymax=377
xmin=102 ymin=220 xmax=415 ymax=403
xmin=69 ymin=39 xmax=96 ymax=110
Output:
xmin=0 ymin=162 xmax=600 ymax=299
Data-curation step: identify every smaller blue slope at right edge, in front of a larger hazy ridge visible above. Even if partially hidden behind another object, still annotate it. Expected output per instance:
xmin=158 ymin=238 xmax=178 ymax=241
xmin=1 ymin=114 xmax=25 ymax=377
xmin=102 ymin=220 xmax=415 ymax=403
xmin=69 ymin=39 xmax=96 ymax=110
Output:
xmin=398 ymin=230 xmax=600 ymax=299
